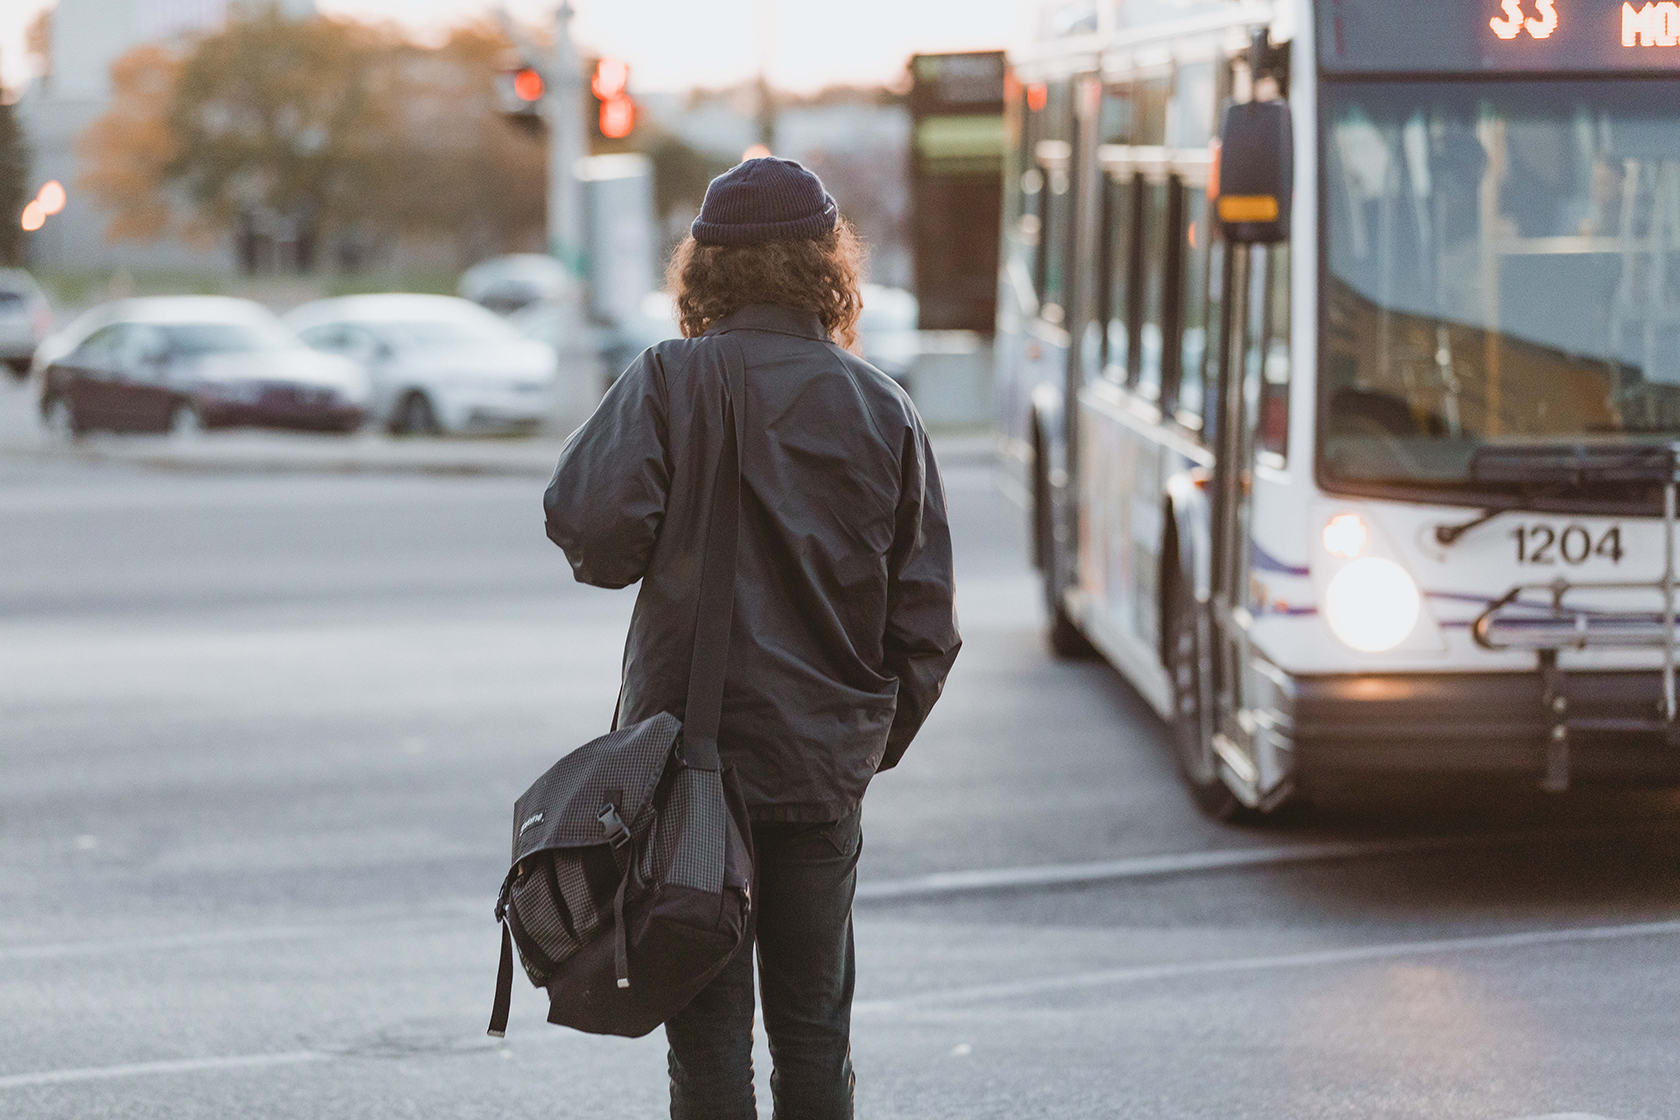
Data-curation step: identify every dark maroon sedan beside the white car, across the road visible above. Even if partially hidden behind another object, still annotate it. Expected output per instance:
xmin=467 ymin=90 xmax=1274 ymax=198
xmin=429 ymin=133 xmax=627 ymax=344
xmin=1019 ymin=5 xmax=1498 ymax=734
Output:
xmin=40 ymin=296 xmax=371 ymax=435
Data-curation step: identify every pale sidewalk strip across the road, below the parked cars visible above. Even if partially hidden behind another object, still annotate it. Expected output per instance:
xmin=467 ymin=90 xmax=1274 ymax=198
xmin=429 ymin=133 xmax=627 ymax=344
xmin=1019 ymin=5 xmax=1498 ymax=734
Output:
xmin=0 ymin=381 xmax=993 ymax=479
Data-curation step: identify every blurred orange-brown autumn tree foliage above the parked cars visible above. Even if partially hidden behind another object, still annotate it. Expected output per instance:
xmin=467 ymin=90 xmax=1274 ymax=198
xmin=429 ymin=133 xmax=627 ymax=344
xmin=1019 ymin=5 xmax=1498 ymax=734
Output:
xmin=82 ymin=10 xmax=543 ymax=267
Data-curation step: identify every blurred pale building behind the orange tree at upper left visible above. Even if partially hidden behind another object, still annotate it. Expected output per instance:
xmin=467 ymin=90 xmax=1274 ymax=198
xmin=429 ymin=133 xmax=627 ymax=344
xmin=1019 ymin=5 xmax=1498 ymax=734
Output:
xmin=18 ymin=0 xmax=314 ymax=272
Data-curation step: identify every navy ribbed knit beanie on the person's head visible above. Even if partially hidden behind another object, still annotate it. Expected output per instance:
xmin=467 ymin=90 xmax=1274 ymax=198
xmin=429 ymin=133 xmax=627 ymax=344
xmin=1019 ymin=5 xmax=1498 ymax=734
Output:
xmin=690 ymin=156 xmax=840 ymax=245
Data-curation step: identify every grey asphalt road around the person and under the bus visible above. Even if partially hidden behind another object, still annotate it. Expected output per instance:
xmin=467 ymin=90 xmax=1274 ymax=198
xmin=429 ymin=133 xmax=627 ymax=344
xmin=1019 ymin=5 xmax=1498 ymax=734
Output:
xmin=0 ymin=433 xmax=1680 ymax=1120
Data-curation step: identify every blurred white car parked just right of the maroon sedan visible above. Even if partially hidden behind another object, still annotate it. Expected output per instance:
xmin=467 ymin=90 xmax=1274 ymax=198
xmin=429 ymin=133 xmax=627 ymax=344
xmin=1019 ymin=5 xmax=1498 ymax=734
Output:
xmin=286 ymin=292 xmax=558 ymax=435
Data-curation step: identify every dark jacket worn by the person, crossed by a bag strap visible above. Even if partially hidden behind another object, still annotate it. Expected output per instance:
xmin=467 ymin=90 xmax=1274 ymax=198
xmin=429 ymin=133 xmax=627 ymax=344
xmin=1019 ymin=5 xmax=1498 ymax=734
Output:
xmin=543 ymin=306 xmax=961 ymax=821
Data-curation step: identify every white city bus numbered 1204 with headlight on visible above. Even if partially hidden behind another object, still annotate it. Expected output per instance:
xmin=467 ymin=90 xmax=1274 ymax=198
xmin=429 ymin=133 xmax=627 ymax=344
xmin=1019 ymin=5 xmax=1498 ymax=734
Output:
xmin=996 ymin=0 xmax=1680 ymax=818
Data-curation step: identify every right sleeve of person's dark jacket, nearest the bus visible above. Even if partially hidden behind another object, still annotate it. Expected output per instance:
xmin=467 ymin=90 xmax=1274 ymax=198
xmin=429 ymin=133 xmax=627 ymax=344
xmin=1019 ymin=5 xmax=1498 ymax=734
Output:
xmin=879 ymin=425 xmax=963 ymax=771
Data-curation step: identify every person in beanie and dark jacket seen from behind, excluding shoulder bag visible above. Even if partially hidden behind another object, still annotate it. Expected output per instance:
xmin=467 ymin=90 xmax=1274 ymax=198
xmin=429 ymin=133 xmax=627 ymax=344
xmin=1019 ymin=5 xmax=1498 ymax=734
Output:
xmin=544 ymin=158 xmax=961 ymax=1120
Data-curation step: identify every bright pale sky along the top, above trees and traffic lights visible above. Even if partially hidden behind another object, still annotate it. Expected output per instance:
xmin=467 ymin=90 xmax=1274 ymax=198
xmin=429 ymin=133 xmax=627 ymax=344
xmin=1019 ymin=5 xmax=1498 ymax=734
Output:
xmin=0 ymin=0 xmax=1021 ymax=92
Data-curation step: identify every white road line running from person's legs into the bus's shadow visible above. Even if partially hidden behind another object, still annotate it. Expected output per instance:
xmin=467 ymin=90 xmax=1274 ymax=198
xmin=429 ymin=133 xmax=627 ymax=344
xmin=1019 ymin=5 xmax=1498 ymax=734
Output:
xmin=857 ymin=828 xmax=1673 ymax=902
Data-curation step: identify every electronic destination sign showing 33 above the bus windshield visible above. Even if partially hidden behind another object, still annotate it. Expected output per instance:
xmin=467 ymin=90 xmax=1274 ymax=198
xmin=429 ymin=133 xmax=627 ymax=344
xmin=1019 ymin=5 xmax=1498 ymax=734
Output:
xmin=1317 ymin=0 xmax=1680 ymax=74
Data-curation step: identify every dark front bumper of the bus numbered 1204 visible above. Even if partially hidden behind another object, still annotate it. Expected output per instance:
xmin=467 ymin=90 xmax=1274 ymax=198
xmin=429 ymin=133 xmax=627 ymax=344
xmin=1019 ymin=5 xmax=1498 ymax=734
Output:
xmin=1290 ymin=672 xmax=1680 ymax=784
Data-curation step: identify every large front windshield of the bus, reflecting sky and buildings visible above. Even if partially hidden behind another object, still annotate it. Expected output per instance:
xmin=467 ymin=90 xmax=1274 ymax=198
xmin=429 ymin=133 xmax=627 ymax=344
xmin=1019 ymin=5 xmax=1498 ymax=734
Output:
xmin=1319 ymin=79 xmax=1680 ymax=489
